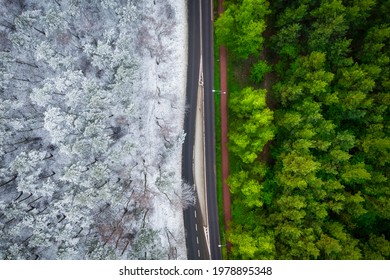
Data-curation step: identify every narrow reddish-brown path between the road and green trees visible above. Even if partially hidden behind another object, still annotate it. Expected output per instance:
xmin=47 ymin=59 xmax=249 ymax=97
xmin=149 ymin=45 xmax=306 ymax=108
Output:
xmin=218 ymin=0 xmax=232 ymax=254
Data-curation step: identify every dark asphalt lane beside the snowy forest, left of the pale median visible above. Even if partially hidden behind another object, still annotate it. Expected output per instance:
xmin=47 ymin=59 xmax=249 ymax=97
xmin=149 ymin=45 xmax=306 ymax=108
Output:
xmin=182 ymin=0 xmax=210 ymax=260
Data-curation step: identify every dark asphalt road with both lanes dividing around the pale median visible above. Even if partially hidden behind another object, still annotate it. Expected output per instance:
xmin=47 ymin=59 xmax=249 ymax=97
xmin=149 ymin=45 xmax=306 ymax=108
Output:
xmin=182 ymin=0 xmax=221 ymax=260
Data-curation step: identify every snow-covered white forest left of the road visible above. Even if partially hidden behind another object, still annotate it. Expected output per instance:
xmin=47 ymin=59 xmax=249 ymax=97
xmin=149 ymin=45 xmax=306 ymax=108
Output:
xmin=0 ymin=0 xmax=192 ymax=259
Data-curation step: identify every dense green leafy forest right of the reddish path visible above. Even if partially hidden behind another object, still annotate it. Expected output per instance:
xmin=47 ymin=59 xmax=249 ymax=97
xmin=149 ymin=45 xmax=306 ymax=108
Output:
xmin=215 ymin=0 xmax=390 ymax=260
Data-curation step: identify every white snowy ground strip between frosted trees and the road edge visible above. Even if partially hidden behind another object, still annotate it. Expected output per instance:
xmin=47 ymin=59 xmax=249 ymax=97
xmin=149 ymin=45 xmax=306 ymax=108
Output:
xmin=128 ymin=0 xmax=187 ymax=259
